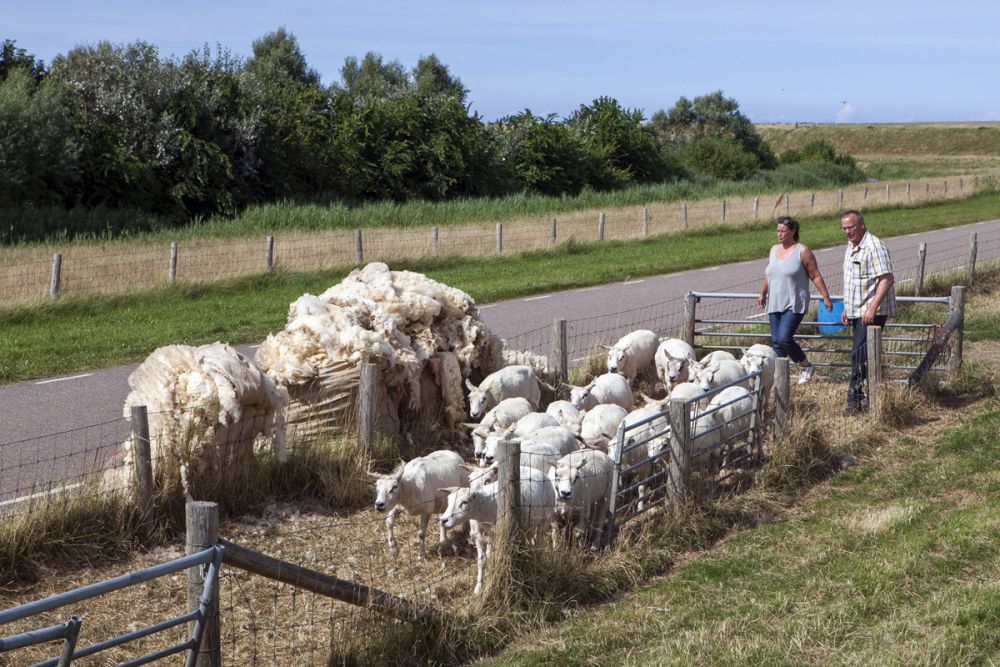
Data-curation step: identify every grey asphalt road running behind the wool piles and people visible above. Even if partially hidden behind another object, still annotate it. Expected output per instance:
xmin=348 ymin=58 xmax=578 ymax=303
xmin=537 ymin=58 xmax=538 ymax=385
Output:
xmin=0 ymin=220 xmax=1000 ymax=500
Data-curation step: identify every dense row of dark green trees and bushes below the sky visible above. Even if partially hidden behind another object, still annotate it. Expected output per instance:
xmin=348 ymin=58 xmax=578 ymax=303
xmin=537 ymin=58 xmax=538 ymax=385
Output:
xmin=0 ymin=29 xmax=860 ymax=241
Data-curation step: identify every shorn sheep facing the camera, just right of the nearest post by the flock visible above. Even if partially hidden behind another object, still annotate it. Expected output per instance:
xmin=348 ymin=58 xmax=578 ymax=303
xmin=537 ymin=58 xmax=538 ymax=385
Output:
xmin=549 ymin=449 xmax=614 ymax=539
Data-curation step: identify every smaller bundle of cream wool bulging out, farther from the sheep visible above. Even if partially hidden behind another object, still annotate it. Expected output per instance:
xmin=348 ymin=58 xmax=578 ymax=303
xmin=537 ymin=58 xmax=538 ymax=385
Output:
xmin=105 ymin=343 xmax=288 ymax=497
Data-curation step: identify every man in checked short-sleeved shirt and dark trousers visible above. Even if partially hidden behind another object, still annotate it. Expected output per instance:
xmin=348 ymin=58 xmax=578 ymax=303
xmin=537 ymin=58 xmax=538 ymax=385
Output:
xmin=840 ymin=210 xmax=896 ymax=415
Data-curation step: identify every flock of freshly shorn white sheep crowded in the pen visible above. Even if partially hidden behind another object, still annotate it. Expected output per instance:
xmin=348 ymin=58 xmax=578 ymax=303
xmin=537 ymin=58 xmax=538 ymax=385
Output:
xmin=370 ymin=330 xmax=775 ymax=595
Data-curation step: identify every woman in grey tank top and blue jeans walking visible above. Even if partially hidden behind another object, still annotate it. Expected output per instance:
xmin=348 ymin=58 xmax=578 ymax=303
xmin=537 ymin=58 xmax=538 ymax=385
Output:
xmin=757 ymin=218 xmax=833 ymax=384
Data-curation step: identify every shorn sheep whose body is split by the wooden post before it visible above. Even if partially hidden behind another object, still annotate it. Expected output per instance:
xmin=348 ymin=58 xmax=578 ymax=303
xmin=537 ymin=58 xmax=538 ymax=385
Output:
xmin=439 ymin=466 xmax=556 ymax=595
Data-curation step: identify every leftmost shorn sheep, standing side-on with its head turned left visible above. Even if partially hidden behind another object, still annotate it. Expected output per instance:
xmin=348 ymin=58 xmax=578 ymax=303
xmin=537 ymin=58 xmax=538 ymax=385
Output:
xmin=369 ymin=449 xmax=469 ymax=560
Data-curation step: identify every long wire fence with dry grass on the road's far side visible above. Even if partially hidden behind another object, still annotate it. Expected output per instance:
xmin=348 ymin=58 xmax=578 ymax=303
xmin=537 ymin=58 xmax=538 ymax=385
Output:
xmin=0 ymin=175 xmax=991 ymax=307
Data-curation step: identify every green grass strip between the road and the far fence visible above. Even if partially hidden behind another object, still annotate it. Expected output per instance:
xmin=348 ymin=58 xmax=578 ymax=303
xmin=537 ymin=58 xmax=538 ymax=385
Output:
xmin=0 ymin=193 xmax=1000 ymax=382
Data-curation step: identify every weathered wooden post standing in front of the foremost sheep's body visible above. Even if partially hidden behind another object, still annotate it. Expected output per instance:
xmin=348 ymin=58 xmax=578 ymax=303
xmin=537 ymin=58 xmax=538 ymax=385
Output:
xmin=486 ymin=440 xmax=524 ymax=599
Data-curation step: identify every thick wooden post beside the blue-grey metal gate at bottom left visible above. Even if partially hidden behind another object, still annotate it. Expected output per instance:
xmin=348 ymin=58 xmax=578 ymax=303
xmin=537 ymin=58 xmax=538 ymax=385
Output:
xmin=185 ymin=501 xmax=222 ymax=667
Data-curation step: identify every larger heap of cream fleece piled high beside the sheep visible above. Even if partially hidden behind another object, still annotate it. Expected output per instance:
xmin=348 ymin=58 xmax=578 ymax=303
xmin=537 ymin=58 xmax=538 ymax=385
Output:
xmin=257 ymin=262 xmax=502 ymax=422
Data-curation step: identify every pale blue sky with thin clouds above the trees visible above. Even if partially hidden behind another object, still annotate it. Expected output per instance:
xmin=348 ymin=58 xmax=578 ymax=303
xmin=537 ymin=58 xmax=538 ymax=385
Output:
xmin=7 ymin=0 xmax=1000 ymax=122
